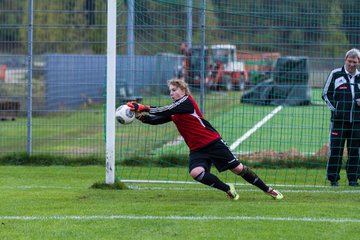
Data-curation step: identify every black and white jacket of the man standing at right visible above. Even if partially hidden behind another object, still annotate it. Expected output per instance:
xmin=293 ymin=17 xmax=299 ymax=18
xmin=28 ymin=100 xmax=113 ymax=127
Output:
xmin=322 ymin=67 xmax=360 ymax=122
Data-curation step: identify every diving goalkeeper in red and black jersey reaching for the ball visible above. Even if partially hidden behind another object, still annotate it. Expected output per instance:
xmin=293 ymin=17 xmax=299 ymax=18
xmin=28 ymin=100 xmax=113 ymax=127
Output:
xmin=127 ymin=79 xmax=283 ymax=200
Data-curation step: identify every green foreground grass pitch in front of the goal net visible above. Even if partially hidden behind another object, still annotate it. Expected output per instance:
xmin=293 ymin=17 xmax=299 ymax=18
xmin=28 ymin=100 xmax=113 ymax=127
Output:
xmin=0 ymin=166 xmax=360 ymax=240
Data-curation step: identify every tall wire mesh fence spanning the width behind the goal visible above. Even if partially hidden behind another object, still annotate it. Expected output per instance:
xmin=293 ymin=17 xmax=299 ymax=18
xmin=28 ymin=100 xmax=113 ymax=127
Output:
xmin=0 ymin=0 xmax=360 ymax=186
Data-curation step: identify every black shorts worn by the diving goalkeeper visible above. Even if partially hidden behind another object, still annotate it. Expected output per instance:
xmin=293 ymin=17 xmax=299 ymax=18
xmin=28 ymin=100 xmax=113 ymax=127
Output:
xmin=189 ymin=139 xmax=240 ymax=172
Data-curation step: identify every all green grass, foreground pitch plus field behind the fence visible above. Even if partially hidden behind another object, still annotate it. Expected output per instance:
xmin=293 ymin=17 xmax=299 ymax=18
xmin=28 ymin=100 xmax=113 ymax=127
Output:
xmin=0 ymin=91 xmax=360 ymax=240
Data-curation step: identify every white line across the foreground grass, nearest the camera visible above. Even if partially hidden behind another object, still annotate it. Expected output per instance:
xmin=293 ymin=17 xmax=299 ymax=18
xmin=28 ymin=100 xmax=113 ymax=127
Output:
xmin=0 ymin=215 xmax=360 ymax=223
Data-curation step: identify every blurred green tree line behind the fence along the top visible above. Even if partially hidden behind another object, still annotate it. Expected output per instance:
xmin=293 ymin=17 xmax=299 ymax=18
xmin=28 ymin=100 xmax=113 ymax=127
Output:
xmin=0 ymin=0 xmax=360 ymax=54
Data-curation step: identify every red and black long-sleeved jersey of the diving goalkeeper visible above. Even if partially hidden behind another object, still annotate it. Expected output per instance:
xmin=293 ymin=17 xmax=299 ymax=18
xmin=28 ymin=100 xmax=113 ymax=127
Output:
xmin=142 ymin=95 xmax=221 ymax=151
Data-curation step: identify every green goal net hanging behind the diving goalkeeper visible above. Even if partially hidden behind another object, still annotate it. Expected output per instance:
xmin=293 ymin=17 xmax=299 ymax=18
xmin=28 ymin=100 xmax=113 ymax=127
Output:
xmin=106 ymin=0 xmax=358 ymax=187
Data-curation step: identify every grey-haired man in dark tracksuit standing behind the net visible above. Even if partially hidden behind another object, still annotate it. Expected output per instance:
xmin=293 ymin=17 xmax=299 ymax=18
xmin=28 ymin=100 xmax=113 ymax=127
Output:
xmin=322 ymin=48 xmax=360 ymax=186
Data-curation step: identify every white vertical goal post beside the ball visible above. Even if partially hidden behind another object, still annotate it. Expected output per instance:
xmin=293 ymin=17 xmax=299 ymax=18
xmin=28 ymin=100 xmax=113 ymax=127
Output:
xmin=105 ymin=0 xmax=116 ymax=184
